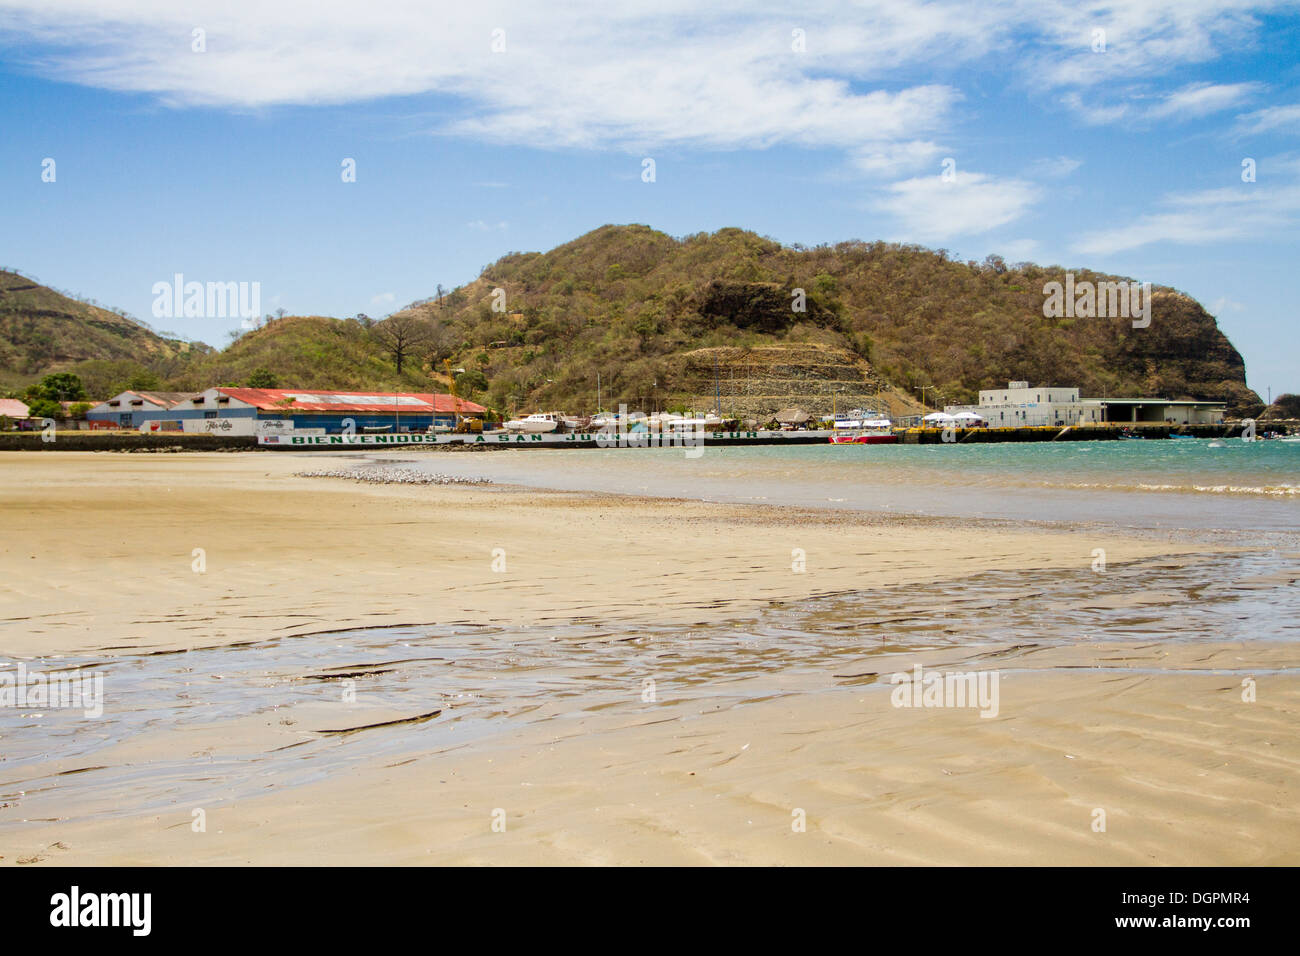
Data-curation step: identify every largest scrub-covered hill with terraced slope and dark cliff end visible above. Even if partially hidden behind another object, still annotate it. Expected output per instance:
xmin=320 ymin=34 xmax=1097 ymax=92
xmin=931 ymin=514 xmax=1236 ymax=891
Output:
xmin=384 ymin=225 xmax=1260 ymax=414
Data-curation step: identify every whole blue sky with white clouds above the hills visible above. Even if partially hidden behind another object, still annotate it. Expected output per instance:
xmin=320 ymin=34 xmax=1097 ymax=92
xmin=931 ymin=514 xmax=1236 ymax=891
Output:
xmin=0 ymin=0 xmax=1300 ymax=395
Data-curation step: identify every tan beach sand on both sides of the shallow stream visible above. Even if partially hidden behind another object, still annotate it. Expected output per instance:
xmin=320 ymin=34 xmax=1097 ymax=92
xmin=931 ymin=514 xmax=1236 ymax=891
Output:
xmin=0 ymin=453 xmax=1300 ymax=865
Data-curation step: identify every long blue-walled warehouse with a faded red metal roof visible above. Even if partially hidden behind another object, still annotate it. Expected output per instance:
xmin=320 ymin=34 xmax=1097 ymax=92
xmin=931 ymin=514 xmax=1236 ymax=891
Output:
xmin=168 ymin=388 xmax=488 ymax=434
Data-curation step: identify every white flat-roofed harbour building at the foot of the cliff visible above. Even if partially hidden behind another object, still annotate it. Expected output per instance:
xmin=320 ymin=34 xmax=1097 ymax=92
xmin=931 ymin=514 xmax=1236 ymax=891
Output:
xmin=944 ymin=381 xmax=1226 ymax=428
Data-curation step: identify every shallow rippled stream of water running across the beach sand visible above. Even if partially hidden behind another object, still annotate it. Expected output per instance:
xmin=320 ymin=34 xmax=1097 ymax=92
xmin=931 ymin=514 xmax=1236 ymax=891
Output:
xmin=0 ymin=551 xmax=1300 ymax=832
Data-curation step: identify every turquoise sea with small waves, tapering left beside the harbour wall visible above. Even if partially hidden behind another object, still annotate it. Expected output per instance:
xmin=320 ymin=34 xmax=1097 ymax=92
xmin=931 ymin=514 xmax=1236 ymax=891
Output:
xmin=397 ymin=440 xmax=1300 ymax=536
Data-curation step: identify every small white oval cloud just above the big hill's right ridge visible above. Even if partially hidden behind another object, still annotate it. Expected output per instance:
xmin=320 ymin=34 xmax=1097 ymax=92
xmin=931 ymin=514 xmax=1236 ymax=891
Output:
xmin=880 ymin=172 xmax=1041 ymax=242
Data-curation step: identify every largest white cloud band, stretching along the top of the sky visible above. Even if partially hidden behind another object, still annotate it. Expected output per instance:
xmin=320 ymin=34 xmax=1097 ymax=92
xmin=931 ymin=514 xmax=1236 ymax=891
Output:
xmin=0 ymin=0 xmax=1273 ymax=156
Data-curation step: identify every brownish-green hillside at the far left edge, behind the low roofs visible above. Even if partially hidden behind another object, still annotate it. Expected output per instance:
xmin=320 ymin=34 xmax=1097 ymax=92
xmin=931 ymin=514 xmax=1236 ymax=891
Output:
xmin=0 ymin=271 xmax=205 ymax=389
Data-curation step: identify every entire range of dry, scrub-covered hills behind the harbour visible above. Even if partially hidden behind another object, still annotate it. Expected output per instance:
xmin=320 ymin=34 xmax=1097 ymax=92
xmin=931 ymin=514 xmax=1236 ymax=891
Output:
xmin=0 ymin=225 xmax=1262 ymax=415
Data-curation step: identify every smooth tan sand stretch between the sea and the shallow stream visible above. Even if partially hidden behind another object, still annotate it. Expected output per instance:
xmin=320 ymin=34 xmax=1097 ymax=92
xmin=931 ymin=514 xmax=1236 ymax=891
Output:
xmin=0 ymin=453 xmax=1227 ymax=657
